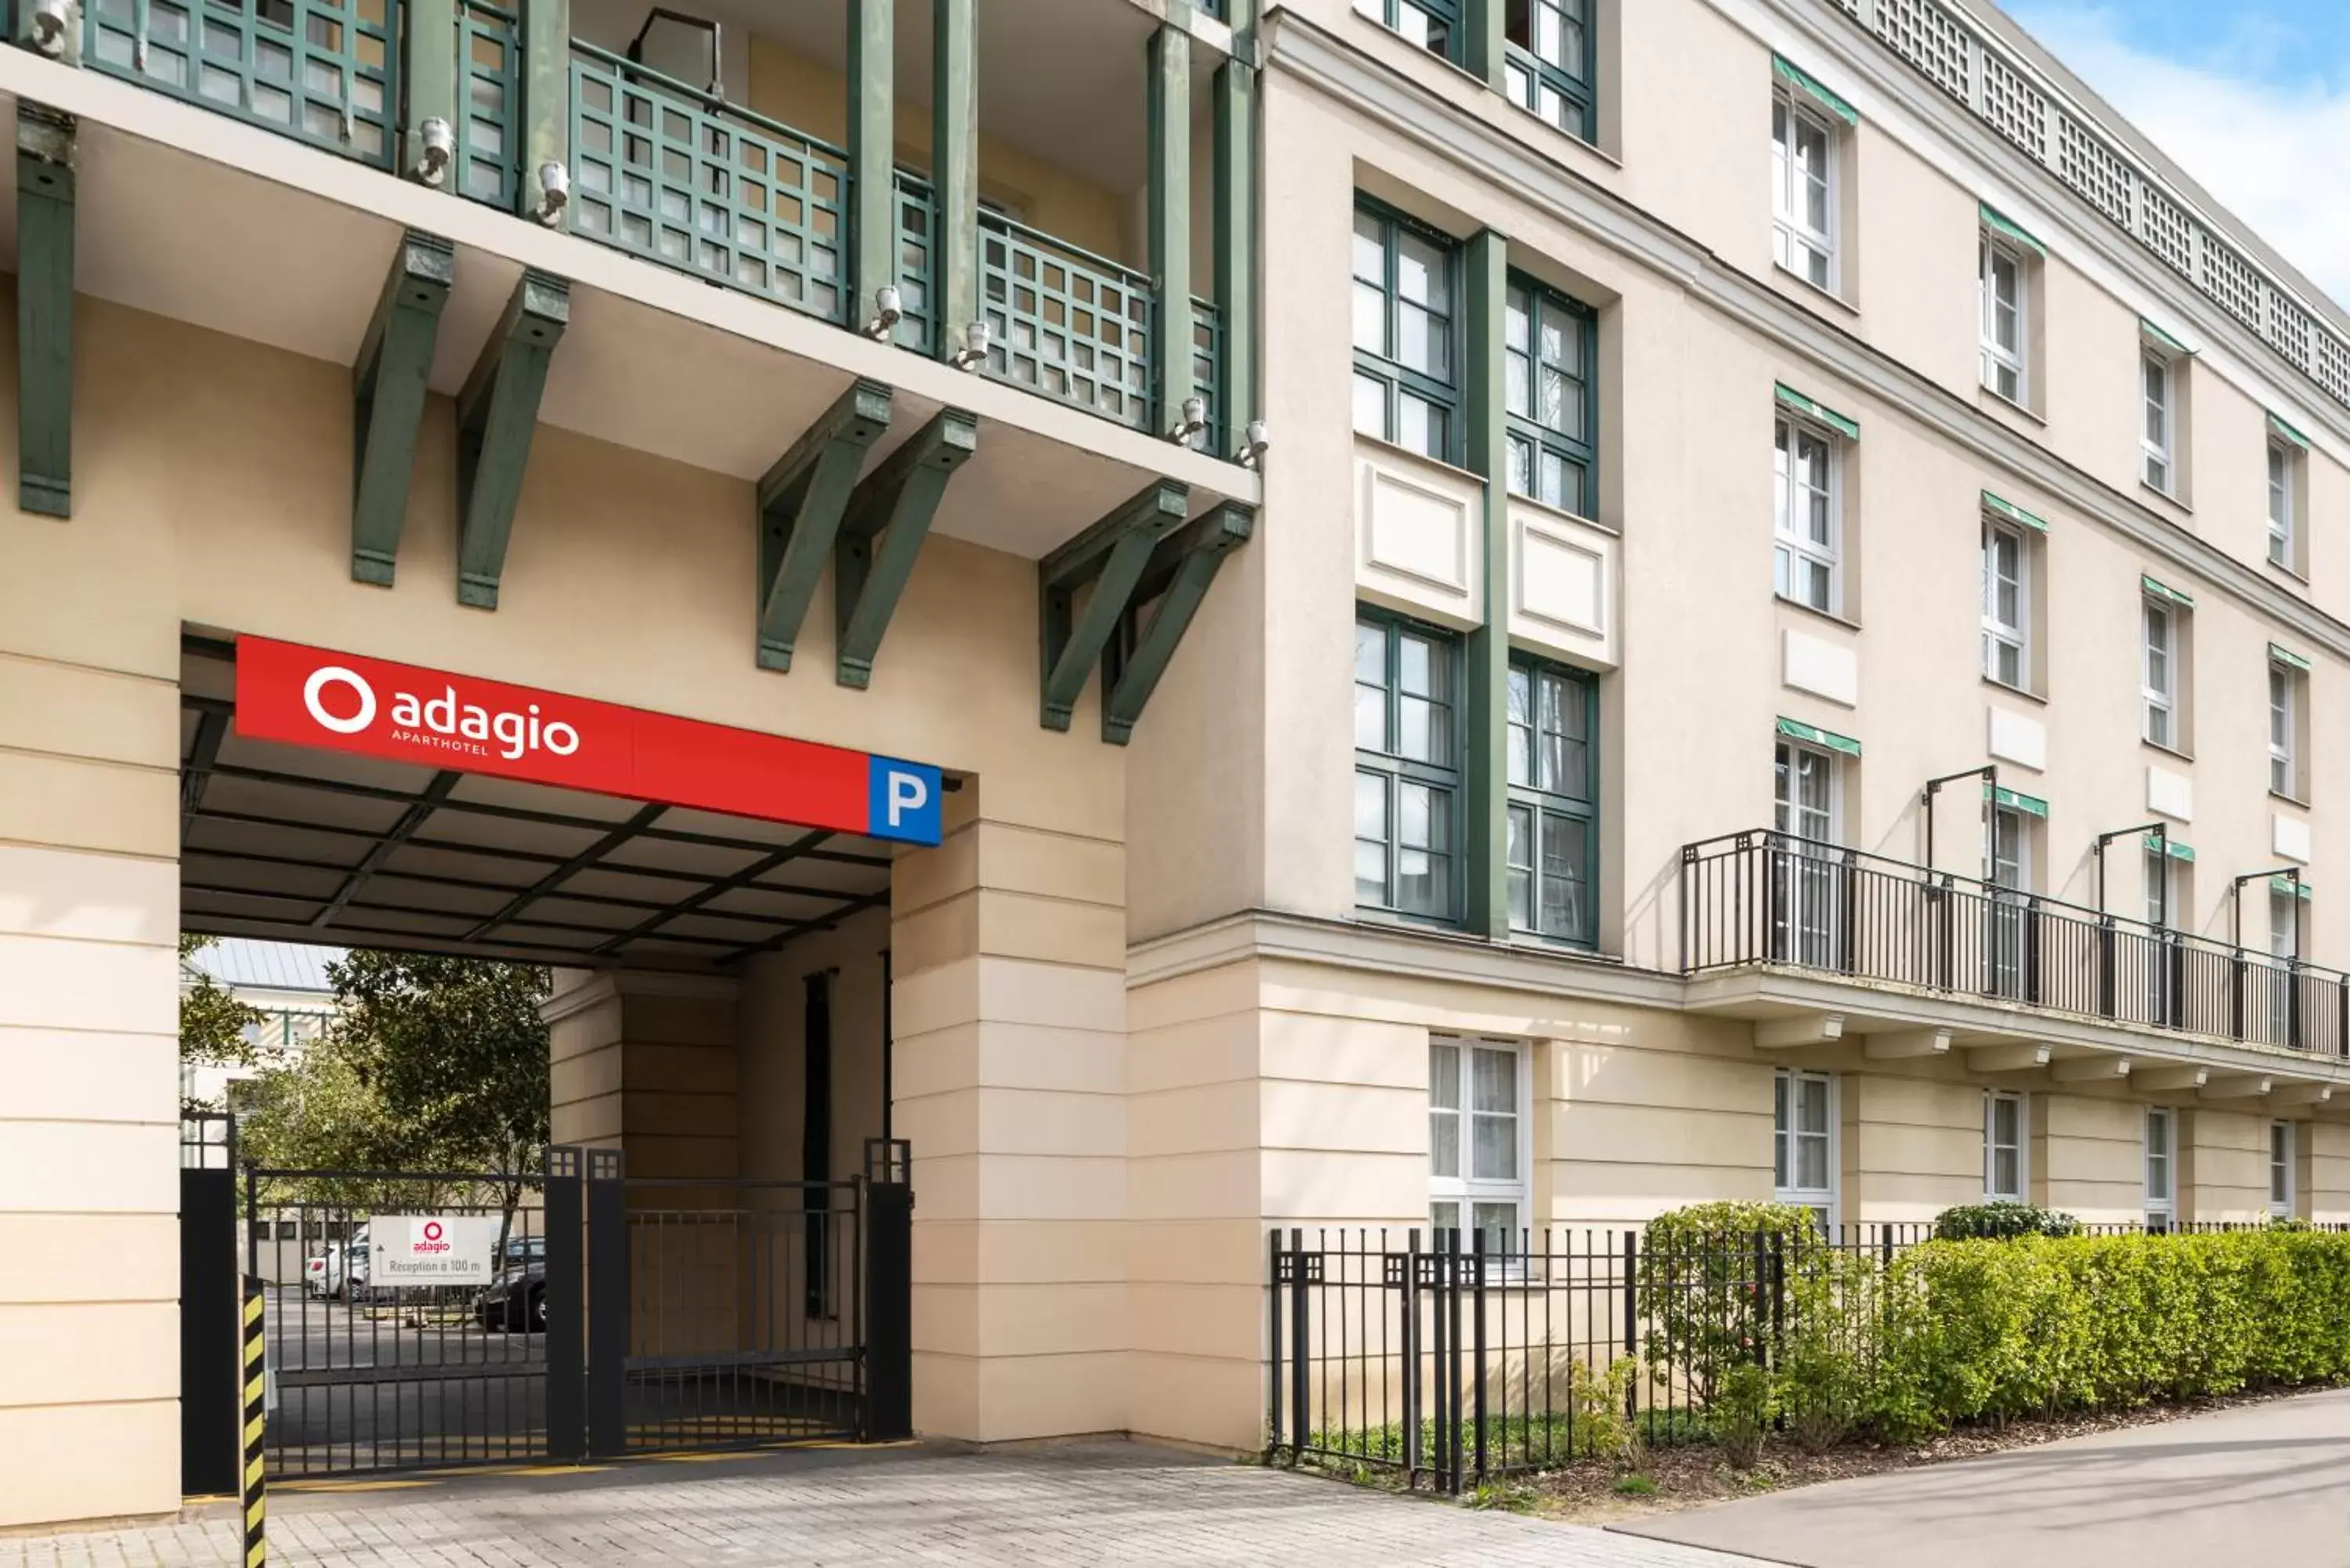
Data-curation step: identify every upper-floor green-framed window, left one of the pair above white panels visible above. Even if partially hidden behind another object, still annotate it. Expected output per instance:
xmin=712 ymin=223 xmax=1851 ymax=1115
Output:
xmin=1354 ymin=202 xmax=1462 ymax=463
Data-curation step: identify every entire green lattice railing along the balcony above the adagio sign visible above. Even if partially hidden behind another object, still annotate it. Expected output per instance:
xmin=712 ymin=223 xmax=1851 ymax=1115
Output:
xmin=57 ymin=0 xmax=1229 ymax=451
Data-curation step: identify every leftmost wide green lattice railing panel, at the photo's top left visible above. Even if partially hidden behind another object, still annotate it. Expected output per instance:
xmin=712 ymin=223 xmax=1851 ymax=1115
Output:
xmin=82 ymin=0 xmax=400 ymax=169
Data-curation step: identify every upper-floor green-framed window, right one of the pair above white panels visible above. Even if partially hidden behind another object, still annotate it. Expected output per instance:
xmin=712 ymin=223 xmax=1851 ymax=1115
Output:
xmin=1504 ymin=277 xmax=1598 ymax=517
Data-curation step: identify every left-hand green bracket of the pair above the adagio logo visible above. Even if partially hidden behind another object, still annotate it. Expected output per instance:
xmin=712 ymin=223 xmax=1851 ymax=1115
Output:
xmin=350 ymin=228 xmax=456 ymax=587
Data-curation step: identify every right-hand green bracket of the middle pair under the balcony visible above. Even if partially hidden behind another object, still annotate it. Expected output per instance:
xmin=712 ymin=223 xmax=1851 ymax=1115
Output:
xmin=832 ymin=409 xmax=980 ymax=691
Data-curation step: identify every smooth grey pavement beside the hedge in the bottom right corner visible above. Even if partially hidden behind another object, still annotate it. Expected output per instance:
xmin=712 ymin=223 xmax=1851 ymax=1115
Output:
xmin=1626 ymin=1389 xmax=2350 ymax=1568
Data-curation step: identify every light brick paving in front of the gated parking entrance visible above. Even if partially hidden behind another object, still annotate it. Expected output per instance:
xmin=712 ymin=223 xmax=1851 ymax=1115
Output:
xmin=0 ymin=1443 xmax=1762 ymax=1568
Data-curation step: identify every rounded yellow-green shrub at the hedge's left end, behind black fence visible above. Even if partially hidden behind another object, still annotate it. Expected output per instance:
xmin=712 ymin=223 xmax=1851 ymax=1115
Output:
xmin=1640 ymin=1204 xmax=1824 ymax=1404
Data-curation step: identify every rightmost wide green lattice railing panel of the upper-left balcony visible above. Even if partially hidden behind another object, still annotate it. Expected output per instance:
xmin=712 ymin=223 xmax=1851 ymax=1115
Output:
xmin=980 ymin=211 xmax=1152 ymax=425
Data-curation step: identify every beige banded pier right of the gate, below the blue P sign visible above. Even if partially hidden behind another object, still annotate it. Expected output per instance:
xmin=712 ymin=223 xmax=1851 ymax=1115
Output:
xmin=891 ymin=786 xmax=1128 ymax=1441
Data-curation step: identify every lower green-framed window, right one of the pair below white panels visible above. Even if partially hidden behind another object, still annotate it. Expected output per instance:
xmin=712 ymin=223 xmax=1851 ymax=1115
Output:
xmin=1509 ymin=658 xmax=1600 ymax=948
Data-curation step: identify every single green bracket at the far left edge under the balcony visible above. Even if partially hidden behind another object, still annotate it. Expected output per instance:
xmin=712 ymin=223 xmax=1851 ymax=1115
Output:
xmin=16 ymin=101 xmax=75 ymax=517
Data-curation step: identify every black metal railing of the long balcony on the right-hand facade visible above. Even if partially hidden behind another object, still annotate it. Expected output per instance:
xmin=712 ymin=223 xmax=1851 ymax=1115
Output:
xmin=1680 ymin=830 xmax=2350 ymax=1056
